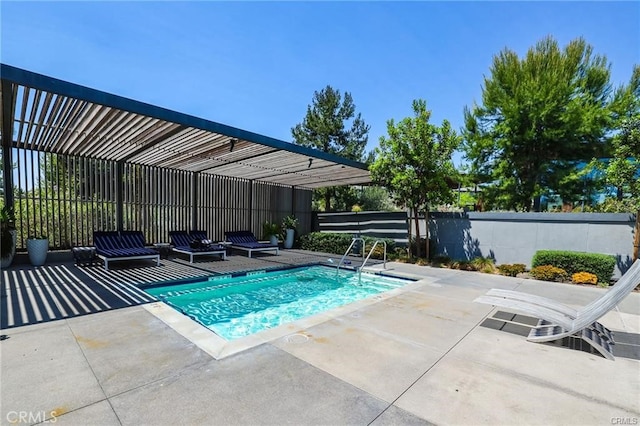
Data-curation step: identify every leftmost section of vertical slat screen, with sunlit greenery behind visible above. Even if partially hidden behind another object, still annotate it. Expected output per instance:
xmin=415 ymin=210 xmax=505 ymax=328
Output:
xmin=14 ymin=148 xmax=116 ymax=249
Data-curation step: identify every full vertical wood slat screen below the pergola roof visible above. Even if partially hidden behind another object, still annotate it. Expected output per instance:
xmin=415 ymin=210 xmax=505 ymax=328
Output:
xmin=5 ymin=148 xmax=311 ymax=251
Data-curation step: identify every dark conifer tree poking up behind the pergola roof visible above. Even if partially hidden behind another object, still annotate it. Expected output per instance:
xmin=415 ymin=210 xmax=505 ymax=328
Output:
xmin=291 ymin=86 xmax=369 ymax=212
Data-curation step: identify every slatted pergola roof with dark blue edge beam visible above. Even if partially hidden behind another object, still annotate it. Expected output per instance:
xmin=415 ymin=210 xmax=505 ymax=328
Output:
xmin=0 ymin=64 xmax=370 ymax=203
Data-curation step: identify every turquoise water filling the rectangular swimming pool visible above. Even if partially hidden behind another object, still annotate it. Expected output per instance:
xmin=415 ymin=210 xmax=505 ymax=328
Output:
xmin=145 ymin=266 xmax=410 ymax=340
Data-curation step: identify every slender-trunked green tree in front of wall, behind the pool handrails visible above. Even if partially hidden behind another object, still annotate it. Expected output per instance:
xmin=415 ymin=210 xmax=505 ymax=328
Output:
xmin=371 ymin=99 xmax=460 ymax=258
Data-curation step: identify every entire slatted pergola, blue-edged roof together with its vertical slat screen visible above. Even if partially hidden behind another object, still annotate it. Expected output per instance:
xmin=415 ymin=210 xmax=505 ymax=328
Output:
xmin=0 ymin=64 xmax=370 ymax=250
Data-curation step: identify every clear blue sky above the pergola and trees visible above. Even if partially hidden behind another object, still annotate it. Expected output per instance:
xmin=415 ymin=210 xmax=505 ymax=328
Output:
xmin=0 ymin=1 xmax=640 ymax=166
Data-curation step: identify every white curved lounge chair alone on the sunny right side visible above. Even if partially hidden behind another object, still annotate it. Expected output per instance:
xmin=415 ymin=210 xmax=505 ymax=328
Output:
xmin=474 ymin=260 xmax=640 ymax=360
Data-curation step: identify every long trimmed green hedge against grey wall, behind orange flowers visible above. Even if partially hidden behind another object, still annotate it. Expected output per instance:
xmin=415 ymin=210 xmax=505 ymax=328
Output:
xmin=531 ymin=250 xmax=616 ymax=285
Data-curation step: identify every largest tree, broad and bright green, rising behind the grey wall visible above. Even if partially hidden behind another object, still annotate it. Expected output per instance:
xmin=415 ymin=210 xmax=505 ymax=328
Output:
xmin=463 ymin=37 xmax=612 ymax=211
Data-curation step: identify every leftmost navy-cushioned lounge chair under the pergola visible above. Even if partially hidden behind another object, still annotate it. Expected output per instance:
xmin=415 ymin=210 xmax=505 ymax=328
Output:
xmin=93 ymin=231 xmax=160 ymax=271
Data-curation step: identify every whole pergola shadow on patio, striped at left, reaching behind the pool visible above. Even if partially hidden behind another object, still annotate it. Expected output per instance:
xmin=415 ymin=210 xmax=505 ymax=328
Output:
xmin=0 ymin=250 xmax=379 ymax=329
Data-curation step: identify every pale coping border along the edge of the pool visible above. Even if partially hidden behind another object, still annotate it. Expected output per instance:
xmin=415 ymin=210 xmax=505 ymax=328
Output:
xmin=142 ymin=265 xmax=428 ymax=360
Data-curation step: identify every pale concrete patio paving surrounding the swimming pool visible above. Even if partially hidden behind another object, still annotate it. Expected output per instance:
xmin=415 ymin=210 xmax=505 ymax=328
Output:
xmin=0 ymin=250 xmax=640 ymax=425
